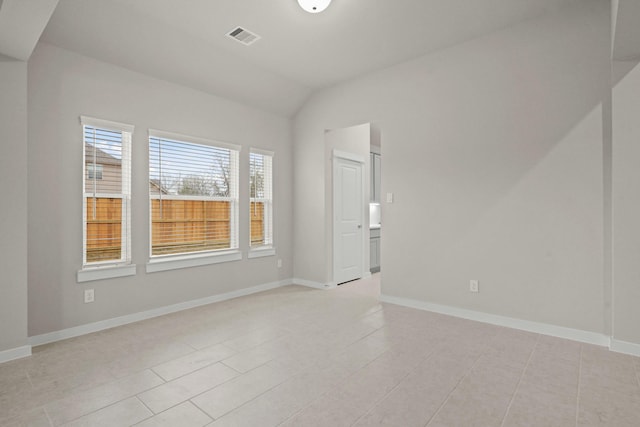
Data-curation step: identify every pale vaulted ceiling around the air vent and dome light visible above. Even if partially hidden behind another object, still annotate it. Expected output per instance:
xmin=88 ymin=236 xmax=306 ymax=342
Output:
xmin=0 ymin=0 xmax=640 ymax=115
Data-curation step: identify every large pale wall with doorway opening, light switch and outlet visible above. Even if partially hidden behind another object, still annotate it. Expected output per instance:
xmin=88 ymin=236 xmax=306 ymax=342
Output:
xmin=294 ymin=0 xmax=611 ymax=333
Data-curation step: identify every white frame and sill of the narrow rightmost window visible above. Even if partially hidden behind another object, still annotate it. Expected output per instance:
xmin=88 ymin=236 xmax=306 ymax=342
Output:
xmin=248 ymin=147 xmax=276 ymax=258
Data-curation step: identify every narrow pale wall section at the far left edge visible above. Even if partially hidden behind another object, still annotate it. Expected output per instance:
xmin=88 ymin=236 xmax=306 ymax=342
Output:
xmin=0 ymin=55 xmax=27 ymax=361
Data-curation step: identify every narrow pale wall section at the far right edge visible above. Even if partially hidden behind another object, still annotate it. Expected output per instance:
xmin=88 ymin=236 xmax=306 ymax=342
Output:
xmin=613 ymin=62 xmax=640 ymax=348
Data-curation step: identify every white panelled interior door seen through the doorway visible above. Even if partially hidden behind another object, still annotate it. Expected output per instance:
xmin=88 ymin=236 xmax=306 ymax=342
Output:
xmin=333 ymin=157 xmax=364 ymax=284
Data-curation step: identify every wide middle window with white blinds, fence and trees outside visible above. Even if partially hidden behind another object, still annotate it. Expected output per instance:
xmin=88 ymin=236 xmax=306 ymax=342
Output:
xmin=149 ymin=130 xmax=239 ymax=258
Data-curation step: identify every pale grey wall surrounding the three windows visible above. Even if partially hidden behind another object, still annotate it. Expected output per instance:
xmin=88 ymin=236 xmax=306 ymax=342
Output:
xmin=27 ymin=44 xmax=292 ymax=336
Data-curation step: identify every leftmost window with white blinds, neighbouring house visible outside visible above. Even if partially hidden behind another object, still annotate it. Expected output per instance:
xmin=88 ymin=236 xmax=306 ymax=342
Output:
xmin=80 ymin=116 xmax=133 ymax=266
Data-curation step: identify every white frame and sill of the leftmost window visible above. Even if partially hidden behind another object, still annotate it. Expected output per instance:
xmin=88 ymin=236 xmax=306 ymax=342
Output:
xmin=77 ymin=116 xmax=136 ymax=282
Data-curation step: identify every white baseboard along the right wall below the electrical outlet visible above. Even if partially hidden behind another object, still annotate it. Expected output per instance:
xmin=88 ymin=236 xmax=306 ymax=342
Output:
xmin=380 ymin=295 xmax=608 ymax=351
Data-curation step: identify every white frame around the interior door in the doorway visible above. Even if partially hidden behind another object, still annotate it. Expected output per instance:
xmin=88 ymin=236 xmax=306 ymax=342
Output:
xmin=331 ymin=149 xmax=369 ymax=286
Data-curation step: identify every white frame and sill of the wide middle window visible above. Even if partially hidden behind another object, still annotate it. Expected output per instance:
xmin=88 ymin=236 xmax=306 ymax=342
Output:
xmin=146 ymin=129 xmax=242 ymax=273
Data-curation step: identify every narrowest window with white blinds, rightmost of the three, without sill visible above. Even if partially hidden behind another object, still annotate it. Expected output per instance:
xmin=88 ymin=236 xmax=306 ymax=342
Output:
xmin=249 ymin=148 xmax=273 ymax=249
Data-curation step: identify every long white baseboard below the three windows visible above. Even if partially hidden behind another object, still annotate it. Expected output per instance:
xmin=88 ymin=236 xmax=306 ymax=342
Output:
xmin=28 ymin=279 xmax=293 ymax=348
